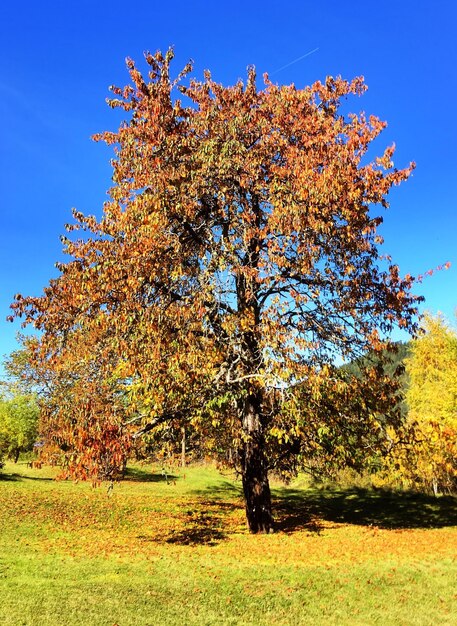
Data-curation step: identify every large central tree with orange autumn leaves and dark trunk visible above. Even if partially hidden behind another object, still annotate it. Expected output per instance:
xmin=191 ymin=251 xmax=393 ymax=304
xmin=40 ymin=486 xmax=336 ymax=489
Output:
xmin=13 ymin=51 xmax=418 ymax=532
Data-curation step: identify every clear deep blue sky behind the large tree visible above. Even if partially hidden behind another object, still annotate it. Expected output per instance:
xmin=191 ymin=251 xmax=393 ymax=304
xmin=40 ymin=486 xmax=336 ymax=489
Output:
xmin=0 ymin=0 xmax=457 ymax=364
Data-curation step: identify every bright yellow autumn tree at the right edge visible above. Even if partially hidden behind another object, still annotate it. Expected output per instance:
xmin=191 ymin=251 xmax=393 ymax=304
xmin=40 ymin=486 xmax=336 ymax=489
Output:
xmin=395 ymin=315 xmax=457 ymax=494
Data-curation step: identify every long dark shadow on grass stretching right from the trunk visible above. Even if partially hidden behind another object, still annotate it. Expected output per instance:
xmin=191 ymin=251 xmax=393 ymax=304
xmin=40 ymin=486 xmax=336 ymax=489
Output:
xmin=274 ymin=488 xmax=457 ymax=533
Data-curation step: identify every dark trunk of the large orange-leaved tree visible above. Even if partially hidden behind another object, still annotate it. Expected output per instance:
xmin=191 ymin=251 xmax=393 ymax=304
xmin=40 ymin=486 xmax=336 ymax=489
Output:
xmin=240 ymin=394 xmax=273 ymax=533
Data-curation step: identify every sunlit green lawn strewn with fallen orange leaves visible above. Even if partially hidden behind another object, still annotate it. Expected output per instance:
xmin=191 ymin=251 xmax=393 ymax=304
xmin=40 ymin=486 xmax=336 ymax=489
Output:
xmin=0 ymin=456 xmax=457 ymax=626
